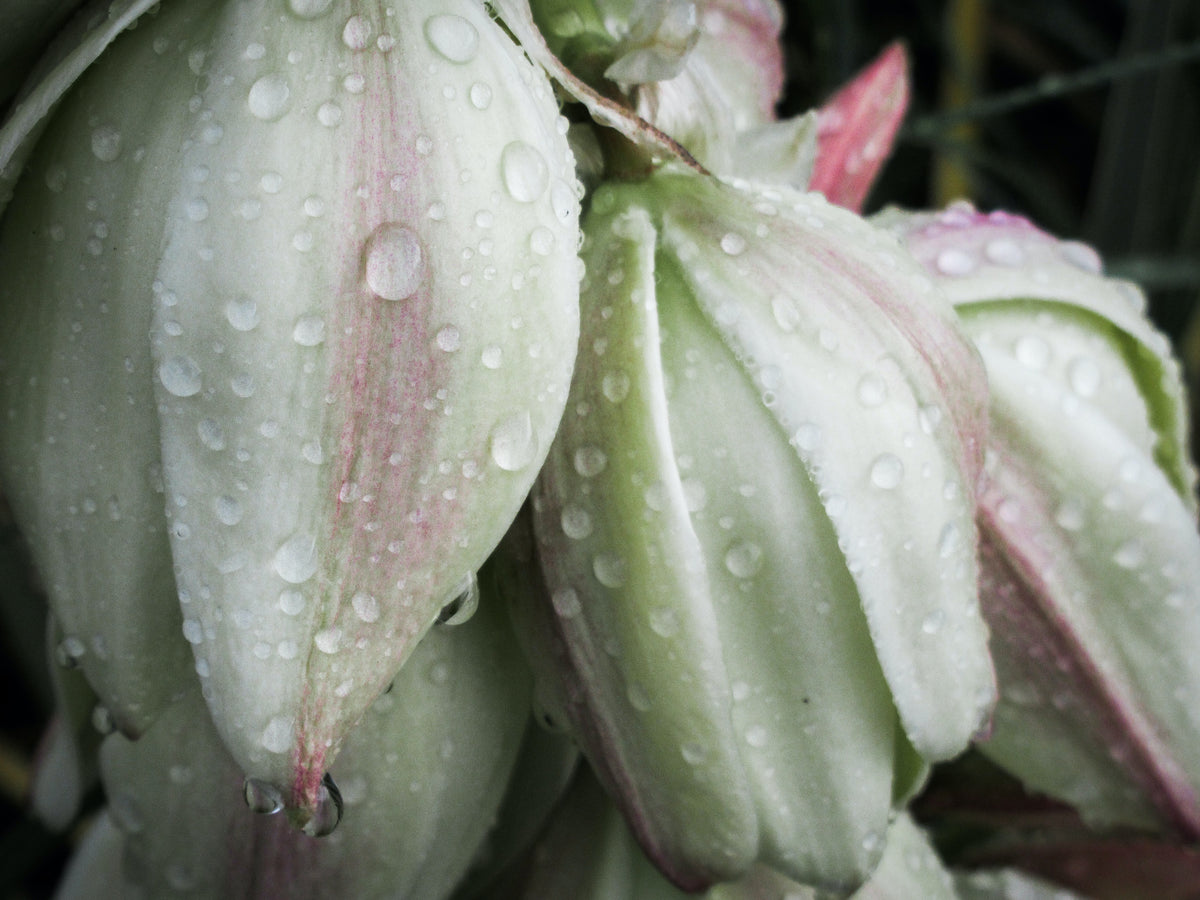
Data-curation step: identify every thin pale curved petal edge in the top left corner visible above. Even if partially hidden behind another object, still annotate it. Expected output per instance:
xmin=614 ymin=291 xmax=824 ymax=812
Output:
xmin=0 ymin=0 xmax=155 ymax=212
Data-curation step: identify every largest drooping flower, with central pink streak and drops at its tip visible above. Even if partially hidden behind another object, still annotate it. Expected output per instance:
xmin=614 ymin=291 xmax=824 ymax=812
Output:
xmin=0 ymin=0 xmax=580 ymax=820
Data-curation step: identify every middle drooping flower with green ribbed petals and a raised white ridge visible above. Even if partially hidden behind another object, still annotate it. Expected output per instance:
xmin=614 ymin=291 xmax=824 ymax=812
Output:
xmin=509 ymin=173 xmax=994 ymax=889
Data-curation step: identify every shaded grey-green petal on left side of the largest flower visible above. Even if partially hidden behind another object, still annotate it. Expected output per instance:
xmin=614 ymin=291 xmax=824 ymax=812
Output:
xmin=0 ymin=2 xmax=214 ymax=734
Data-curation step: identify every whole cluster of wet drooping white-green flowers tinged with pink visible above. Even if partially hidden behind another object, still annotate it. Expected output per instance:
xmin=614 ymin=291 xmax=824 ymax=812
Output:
xmin=0 ymin=0 xmax=1200 ymax=900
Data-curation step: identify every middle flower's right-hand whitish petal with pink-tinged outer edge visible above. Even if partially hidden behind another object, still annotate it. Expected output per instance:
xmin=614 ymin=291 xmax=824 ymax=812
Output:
xmin=662 ymin=172 xmax=992 ymax=758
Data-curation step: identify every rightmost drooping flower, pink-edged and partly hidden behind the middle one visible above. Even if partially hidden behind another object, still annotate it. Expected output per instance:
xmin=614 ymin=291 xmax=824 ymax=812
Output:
xmin=882 ymin=204 xmax=1200 ymax=838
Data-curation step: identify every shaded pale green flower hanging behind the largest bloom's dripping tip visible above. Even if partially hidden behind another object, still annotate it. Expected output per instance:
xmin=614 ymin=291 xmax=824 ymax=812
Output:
xmin=51 ymin=588 xmax=529 ymax=900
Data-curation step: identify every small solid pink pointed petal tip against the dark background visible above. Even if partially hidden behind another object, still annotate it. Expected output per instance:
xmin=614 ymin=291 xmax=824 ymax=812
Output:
xmin=809 ymin=43 xmax=908 ymax=210
